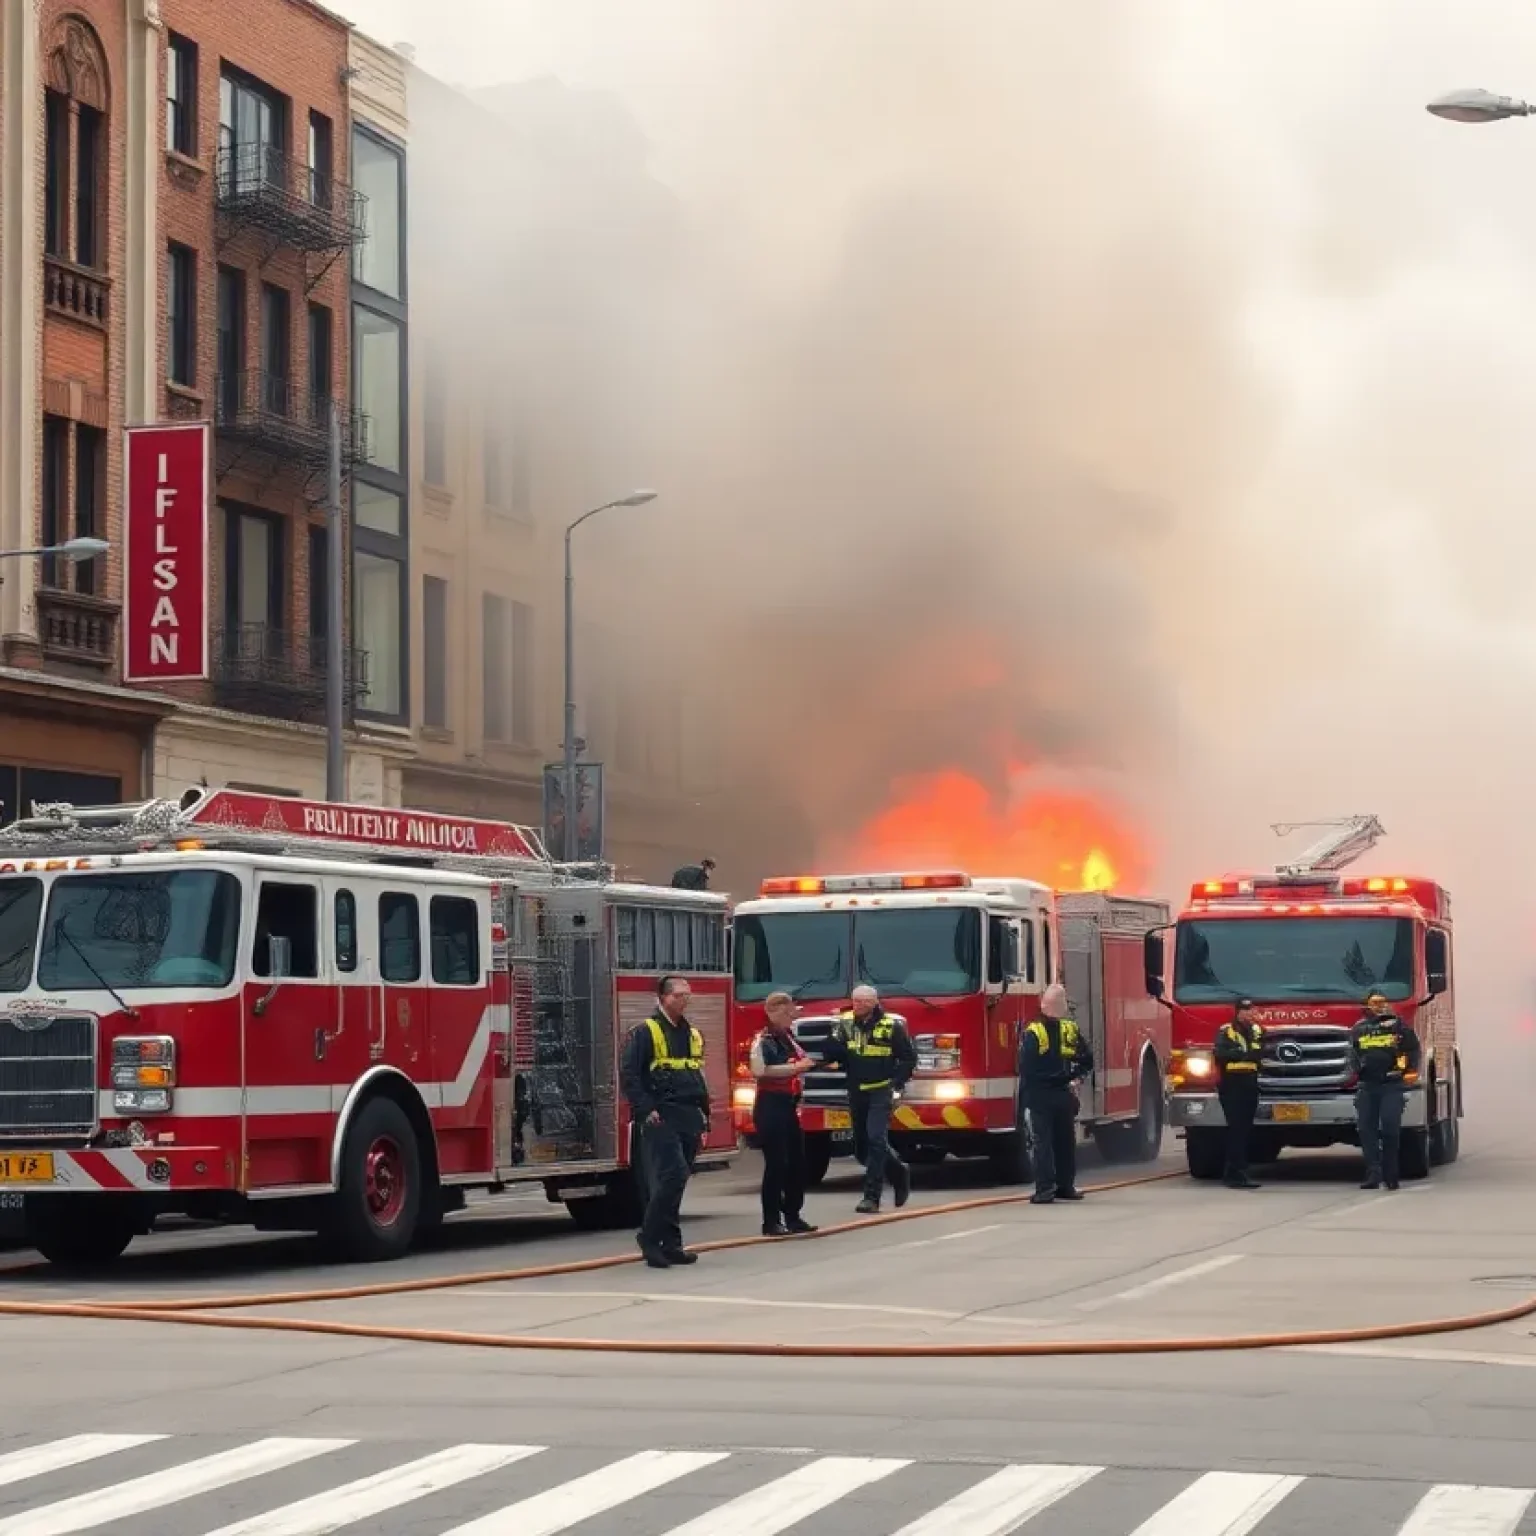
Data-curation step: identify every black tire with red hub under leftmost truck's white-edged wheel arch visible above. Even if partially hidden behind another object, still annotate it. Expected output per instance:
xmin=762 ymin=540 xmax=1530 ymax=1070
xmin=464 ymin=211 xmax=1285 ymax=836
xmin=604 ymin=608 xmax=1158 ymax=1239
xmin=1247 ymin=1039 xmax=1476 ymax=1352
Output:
xmin=321 ymin=1097 xmax=422 ymax=1264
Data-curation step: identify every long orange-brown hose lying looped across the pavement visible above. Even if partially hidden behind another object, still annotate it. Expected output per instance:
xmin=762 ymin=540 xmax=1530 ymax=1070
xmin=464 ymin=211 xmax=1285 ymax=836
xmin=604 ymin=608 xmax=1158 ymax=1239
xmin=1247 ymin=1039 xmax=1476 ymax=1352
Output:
xmin=0 ymin=1172 xmax=1517 ymax=1359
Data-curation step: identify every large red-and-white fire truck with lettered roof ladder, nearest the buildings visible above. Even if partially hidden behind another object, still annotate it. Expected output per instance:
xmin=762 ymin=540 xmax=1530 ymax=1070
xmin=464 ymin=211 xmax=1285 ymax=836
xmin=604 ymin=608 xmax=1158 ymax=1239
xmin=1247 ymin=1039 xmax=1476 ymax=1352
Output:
xmin=0 ymin=790 xmax=736 ymax=1264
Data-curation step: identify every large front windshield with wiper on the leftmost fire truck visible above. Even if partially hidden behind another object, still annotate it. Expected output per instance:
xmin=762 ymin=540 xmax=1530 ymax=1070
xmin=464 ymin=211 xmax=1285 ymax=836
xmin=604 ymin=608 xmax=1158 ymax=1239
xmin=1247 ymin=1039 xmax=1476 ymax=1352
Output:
xmin=36 ymin=869 xmax=240 ymax=992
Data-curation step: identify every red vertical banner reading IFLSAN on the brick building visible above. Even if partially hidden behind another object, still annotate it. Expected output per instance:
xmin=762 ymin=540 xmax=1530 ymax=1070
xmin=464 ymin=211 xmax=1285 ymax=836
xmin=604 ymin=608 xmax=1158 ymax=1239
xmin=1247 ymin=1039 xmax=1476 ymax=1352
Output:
xmin=123 ymin=421 xmax=214 ymax=682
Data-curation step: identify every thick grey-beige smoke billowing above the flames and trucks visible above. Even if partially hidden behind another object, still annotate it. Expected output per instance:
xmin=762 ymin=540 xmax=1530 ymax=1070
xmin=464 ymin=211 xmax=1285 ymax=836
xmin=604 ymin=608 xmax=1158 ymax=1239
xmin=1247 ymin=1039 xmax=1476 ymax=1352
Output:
xmin=350 ymin=0 xmax=1536 ymax=1099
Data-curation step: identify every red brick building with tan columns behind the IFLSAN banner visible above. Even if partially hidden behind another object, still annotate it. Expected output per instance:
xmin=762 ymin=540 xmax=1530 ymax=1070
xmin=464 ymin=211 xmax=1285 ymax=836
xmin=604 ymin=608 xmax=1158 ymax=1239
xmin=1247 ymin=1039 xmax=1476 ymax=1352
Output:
xmin=0 ymin=0 xmax=410 ymax=816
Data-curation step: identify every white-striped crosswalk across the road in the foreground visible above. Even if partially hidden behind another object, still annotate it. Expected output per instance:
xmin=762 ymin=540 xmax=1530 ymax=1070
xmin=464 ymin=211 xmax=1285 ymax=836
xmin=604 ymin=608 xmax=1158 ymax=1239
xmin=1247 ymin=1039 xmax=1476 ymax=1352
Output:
xmin=0 ymin=1433 xmax=1536 ymax=1536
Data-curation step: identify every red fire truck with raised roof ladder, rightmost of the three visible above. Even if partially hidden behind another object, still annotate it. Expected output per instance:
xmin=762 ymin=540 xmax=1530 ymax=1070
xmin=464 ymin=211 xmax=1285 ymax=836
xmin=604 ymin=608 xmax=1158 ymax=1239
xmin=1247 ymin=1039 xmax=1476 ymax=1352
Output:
xmin=1144 ymin=816 xmax=1462 ymax=1178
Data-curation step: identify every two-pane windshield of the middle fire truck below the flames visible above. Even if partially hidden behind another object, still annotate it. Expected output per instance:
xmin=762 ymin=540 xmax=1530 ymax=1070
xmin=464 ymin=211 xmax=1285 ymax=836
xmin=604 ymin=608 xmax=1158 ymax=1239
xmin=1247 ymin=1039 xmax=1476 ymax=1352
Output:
xmin=734 ymin=908 xmax=982 ymax=1003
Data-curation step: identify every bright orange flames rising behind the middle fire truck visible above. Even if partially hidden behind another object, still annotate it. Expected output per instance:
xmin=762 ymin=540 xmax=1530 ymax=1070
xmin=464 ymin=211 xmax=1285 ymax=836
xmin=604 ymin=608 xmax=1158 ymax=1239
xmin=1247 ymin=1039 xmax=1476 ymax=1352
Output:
xmin=825 ymin=770 xmax=1147 ymax=891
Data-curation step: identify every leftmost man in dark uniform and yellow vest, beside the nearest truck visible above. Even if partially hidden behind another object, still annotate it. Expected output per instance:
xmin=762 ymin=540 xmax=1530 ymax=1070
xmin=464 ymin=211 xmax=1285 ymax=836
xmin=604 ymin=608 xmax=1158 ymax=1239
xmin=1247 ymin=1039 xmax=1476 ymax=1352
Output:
xmin=621 ymin=975 xmax=710 ymax=1269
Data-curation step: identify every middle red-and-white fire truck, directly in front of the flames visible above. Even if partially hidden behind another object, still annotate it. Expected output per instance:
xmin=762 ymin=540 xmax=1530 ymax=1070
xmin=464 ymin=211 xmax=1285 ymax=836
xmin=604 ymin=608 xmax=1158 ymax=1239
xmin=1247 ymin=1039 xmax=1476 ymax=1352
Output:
xmin=731 ymin=871 xmax=1169 ymax=1184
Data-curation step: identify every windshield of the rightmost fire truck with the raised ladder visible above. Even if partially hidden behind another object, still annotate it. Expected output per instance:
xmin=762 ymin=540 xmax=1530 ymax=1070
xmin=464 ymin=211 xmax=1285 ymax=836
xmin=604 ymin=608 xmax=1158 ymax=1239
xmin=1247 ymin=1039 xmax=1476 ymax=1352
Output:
xmin=1174 ymin=917 xmax=1413 ymax=1003
